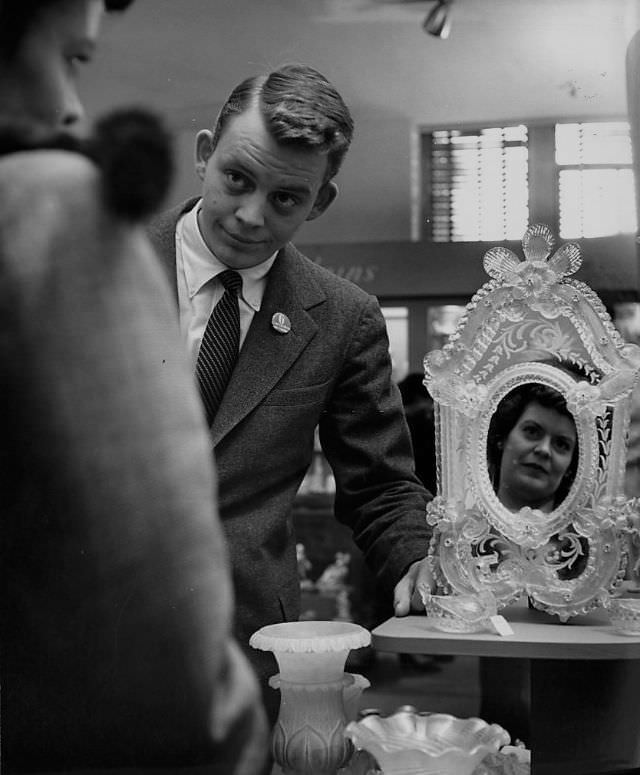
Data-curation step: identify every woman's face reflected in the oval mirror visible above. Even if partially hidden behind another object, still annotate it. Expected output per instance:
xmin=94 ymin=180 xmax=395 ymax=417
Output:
xmin=498 ymin=403 xmax=577 ymax=511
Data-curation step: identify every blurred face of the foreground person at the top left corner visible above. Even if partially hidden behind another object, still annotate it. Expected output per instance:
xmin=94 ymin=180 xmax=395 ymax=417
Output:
xmin=0 ymin=0 xmax=104 ymax=128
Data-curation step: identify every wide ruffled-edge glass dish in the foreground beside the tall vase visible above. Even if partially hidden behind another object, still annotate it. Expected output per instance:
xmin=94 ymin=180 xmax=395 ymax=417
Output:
xmin=345 ymin=707 xmax=511 ymax=775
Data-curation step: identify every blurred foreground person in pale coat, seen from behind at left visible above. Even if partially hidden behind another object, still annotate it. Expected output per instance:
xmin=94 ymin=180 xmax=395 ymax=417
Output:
xmin=0 ymin=0 xmax=267 ymax=775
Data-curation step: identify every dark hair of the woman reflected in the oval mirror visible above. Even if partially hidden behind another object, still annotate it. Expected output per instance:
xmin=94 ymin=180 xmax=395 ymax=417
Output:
xmin=487 ymin=382 xmax=579 ymax=507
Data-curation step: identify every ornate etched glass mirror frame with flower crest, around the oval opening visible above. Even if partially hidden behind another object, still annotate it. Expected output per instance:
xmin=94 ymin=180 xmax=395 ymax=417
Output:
xmin=424 ymin=224 xmax=640 ymax=620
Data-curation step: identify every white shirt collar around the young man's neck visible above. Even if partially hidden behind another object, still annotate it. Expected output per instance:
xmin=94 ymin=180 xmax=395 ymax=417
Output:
xmin=182 ymin=200 xmax=278 ymax=312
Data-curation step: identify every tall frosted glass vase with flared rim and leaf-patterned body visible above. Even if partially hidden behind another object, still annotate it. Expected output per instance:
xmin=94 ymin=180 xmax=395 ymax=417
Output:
xmin=249 ymin=621 xmax=371 ymax=775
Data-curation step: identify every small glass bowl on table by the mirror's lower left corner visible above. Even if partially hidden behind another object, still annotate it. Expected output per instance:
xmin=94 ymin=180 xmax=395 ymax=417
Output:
xmin=420 ymin=590 xmax=498 ymax=632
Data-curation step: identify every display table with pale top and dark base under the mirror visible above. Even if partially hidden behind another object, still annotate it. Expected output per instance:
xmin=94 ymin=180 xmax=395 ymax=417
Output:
xmin=372 ymin=603 xmax=640 ymax=775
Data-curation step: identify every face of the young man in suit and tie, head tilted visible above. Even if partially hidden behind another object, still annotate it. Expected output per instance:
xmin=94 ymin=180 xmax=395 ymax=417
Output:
xmin=196 ymin=105 xmax=336 ymax=269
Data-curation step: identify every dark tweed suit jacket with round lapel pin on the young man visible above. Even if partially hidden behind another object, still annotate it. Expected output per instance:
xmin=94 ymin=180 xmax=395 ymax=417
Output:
xmin=150 ymin=200 xmax=429 ymax=677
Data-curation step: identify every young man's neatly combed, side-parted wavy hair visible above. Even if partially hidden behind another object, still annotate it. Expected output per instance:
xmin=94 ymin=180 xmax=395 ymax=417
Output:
xmin=213 ymin=64 xmax=353 ymax=182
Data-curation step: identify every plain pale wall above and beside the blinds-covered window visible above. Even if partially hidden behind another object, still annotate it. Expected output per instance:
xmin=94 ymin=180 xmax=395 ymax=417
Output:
xmin=83 ymin=0 xmax=640 ymax=244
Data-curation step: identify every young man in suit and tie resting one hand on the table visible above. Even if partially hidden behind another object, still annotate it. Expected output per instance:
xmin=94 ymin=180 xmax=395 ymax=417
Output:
xmin=151 ymin=65 xmax=429 ymax=712
